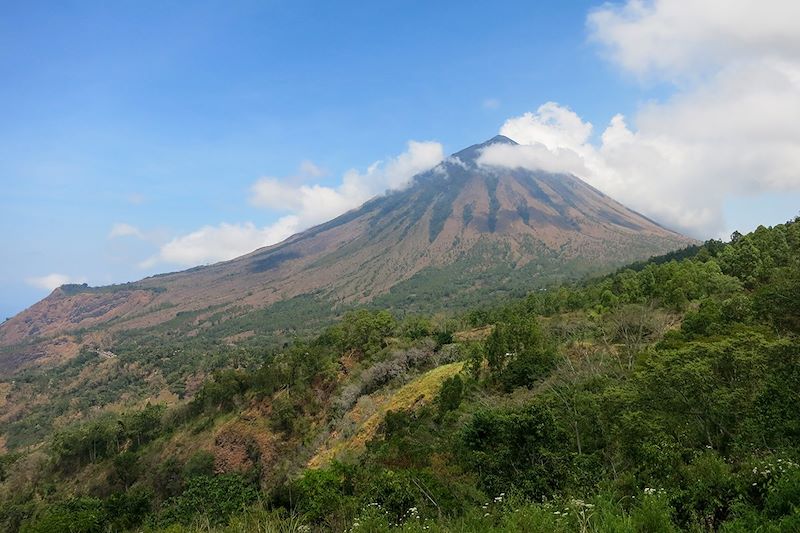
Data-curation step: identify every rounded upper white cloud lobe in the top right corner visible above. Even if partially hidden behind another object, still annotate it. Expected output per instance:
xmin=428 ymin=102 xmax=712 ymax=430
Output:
xmin=587 ymin=0 xmax=800 ymax=81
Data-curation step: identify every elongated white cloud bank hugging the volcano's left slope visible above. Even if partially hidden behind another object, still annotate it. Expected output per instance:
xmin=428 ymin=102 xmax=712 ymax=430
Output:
xmin=140 ymin=141 xmax=444 ymax=268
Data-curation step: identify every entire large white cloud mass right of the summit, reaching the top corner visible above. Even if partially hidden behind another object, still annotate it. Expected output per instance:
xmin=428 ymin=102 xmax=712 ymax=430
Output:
xmin=482 ymin=0 xmax=800 ymax=237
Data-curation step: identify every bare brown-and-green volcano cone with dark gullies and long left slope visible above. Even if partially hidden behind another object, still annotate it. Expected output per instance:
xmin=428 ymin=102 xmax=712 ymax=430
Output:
xmin=0 ymin=135 xmax=692 ymax=371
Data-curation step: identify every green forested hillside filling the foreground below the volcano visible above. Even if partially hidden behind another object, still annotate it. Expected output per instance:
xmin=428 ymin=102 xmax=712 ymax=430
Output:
xmin=0 ymin=218 xmax=800 ymax=532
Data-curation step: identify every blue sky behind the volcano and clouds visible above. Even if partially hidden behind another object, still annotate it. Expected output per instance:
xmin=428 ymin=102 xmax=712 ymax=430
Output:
xmin=0 ymin=1 xmax=800 ymax=318
